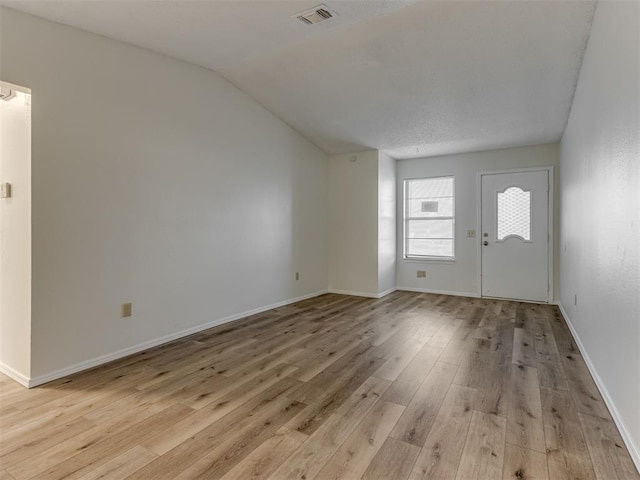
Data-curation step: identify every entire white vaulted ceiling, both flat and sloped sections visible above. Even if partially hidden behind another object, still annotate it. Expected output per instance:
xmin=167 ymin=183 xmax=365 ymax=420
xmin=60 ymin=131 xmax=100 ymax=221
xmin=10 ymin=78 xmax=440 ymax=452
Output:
xmin=1 ymin=0 xmax=595 ymax=158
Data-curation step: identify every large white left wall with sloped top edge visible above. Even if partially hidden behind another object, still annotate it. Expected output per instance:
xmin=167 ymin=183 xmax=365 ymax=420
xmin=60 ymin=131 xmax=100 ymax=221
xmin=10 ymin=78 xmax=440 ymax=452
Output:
xmin=0 ymin=9 xmax=327 ymax=378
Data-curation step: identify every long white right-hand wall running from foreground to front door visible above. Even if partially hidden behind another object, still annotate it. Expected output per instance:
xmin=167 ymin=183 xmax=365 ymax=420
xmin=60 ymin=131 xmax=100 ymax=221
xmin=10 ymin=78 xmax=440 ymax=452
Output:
xmin=560 ymin=1 xmax=640 ymax=468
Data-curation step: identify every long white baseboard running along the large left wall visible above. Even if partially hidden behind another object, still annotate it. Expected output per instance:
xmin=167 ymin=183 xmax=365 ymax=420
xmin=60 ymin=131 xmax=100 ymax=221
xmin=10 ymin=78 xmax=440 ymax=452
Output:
xmin=25 ymin=290 xmax=327 ymax=388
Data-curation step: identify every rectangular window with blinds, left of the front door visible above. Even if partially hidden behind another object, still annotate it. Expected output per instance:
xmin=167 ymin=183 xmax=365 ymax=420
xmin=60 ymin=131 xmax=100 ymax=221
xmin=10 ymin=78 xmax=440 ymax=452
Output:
xmin=404 ymin=177 xmax=455 ymax=259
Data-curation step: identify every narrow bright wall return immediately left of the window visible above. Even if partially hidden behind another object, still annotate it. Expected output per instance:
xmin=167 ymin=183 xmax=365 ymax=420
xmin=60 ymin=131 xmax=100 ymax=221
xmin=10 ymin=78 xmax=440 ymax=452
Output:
xmin=378 ymin=152 xmax=397 ymax=295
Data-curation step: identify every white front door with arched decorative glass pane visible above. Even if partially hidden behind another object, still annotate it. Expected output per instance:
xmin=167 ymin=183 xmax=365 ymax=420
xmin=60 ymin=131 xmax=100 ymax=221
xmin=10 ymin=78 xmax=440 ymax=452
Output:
xmin=480 ymin=170 xmax=550 ymax=302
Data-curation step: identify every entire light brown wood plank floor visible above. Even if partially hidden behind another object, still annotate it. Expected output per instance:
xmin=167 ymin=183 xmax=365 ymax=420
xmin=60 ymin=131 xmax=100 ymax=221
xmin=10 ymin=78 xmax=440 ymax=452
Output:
xmin=0 ymin=292 xmax=640 ymax=480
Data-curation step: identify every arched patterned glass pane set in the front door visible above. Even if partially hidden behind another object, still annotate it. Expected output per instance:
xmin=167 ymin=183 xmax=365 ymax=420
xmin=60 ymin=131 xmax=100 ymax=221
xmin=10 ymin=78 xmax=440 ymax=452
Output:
xmin=497 ymin=187 xmax=531 ymax=241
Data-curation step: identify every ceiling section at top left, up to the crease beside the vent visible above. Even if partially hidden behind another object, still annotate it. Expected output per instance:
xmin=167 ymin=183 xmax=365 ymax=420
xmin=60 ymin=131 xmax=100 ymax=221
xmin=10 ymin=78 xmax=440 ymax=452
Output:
xmin=0 ymin=0 xmax=417 ymax=71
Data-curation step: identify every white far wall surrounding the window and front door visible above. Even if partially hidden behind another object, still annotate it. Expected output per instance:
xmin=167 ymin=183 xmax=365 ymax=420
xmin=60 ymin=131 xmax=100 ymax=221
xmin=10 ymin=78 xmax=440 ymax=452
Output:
xmin=397 ymin=144 xmax=559 ymax=298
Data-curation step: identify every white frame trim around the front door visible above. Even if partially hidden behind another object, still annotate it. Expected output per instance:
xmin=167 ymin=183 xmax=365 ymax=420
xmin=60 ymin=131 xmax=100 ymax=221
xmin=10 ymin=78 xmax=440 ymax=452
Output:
xmin=476 ymin=165 xmax=555 ymax=304
